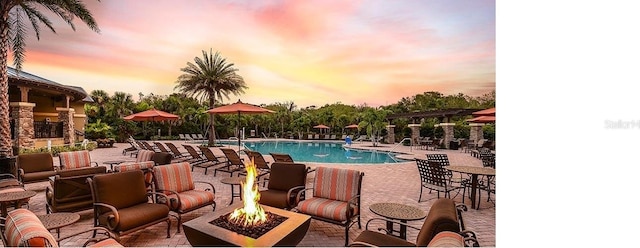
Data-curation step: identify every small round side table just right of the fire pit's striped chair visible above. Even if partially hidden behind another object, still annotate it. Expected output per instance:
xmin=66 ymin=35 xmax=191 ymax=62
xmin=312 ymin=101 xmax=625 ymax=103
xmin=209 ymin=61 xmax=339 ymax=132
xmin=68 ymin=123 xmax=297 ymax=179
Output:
xmin=369 ymin=203 xmax=427 ymax=240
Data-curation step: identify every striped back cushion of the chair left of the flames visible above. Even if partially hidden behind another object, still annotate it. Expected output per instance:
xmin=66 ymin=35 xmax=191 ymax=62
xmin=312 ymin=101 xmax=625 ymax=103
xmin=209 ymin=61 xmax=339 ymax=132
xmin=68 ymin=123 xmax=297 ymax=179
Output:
xmin=153 ymin=162 xmax=195 ymax=194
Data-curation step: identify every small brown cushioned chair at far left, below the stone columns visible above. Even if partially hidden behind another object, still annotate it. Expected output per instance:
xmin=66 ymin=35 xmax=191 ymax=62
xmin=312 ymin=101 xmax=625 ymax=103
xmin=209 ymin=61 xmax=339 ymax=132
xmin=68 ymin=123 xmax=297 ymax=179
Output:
xmin=16 ymin=152 xmax=57 ymax=184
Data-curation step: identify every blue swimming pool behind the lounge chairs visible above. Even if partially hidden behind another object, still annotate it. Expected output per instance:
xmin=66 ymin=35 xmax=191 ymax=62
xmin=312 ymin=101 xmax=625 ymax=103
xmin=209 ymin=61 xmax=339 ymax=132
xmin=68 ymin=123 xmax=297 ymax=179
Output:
xmin=223 ymin=141 xmax=406 ymax=164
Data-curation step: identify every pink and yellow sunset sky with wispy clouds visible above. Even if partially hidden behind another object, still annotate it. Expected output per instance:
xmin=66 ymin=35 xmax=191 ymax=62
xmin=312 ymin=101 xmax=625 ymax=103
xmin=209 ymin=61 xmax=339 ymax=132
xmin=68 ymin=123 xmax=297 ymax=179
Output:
xmin=9 ymin=0 xmax=496 ymax=107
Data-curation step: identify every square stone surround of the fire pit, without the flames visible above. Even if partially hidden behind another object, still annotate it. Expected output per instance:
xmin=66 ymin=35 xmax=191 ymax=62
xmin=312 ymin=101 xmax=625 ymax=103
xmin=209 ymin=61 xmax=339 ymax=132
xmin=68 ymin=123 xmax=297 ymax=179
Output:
xmin=182 ymin=202 xmax=311 ymax=247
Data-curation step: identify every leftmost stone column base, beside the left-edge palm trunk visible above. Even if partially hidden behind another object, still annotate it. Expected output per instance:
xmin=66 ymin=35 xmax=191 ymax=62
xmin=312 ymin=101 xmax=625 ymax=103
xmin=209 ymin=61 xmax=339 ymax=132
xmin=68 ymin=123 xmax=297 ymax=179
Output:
xmin=9 ymin=102 xmax=36 ymax=148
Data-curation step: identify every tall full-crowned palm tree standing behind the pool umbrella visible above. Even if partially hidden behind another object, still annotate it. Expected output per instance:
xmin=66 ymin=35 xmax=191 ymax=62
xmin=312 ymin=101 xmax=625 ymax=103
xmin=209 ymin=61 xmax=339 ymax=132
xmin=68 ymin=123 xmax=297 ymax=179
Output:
xmin=175 ymin=50 xmax=248 ymax=146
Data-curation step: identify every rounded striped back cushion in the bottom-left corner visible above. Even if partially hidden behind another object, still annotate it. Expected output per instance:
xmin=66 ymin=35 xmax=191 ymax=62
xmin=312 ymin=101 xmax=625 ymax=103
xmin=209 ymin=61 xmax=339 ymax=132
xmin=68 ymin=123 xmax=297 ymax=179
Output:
xmin=5 ymin=208 xmax=58 ymax=247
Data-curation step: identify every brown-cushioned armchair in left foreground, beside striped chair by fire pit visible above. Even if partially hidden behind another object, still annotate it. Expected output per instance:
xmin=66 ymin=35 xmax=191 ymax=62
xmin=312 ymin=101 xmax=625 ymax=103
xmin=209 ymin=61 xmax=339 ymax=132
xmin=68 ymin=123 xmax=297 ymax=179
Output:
xmin=87 ymin=170 xmax=171 ymax=238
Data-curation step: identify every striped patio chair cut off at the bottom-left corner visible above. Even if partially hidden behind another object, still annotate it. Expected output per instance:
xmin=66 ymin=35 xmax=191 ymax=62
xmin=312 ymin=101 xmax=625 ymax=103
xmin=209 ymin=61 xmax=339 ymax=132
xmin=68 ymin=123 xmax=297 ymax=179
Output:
xmin=0 ymin=208 xmax=123 ymax=247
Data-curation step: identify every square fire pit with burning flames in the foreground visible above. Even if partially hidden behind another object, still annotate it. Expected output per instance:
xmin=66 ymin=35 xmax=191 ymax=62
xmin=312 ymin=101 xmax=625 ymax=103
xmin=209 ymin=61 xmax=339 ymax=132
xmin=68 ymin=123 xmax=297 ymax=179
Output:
xmin=182 ymin=161 xmax=311 ymax=246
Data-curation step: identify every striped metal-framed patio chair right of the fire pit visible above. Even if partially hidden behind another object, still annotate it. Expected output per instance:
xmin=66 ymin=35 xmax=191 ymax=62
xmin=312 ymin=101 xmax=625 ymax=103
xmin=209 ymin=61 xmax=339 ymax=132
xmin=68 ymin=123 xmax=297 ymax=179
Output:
xmin=294 ymin=166 xmax=364 ymax=246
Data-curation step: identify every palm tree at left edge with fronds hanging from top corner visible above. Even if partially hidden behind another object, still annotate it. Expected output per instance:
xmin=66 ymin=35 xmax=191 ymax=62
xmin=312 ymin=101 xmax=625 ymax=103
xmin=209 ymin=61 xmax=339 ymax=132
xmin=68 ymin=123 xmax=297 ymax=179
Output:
xmin=0 ymin=0 xmax=100 ymax=156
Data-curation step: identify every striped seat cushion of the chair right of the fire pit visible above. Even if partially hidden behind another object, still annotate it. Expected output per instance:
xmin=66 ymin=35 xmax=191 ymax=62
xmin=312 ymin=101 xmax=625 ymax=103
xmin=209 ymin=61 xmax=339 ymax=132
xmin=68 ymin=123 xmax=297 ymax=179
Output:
xmin=296 ymin=197 xmax=357 ymax=221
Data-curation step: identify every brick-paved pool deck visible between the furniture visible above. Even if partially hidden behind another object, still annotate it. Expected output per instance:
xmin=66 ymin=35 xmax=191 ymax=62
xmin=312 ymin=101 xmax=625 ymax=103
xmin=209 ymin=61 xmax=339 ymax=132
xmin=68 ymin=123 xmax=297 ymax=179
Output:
xmin=13 ymin=140 xmax=496 ymax=247
